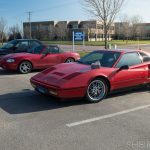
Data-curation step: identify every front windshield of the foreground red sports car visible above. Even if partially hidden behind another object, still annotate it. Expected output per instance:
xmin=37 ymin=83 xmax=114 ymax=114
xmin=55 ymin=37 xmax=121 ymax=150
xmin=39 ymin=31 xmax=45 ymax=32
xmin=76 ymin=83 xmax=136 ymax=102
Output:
xmin=78 ymin=50 xmax=121 ymax=68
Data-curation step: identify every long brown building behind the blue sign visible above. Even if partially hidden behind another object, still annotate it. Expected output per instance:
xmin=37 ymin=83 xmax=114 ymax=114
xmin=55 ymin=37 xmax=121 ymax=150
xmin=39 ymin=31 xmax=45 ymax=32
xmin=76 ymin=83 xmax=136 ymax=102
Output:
xmin=23 ymin=20 xmax=115 ymax=41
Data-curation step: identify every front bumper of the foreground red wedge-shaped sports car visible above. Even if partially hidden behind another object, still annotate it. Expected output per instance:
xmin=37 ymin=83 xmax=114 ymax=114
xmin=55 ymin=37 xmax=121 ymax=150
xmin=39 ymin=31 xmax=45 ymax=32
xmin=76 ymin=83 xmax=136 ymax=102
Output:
xmin=30 ymin=79 xmax=86 ymax=99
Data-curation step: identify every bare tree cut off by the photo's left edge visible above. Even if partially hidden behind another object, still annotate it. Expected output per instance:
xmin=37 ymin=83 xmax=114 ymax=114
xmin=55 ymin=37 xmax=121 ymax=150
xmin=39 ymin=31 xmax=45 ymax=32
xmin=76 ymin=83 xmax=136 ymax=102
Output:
xmin=0 ymin=17 xmax=7 ymax=44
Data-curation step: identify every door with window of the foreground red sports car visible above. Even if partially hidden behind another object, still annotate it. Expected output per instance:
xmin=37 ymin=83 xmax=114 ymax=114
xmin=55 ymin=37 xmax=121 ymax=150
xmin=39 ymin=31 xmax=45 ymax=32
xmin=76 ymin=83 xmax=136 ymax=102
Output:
xmin=111 ymin=52 xmax=148 ymax=89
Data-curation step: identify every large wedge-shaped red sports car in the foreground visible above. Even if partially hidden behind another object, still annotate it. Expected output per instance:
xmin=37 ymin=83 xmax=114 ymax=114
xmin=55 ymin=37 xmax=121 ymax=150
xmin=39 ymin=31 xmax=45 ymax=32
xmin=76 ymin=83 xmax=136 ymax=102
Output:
xmin=30 ymin=50 xmax=150 ymax=102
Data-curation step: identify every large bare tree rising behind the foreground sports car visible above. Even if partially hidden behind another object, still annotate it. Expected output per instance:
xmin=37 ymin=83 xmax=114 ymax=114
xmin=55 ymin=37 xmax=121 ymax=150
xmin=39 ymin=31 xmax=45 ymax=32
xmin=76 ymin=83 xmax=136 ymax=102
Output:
xmin=83 ymin=0 xmax=125 ymax=48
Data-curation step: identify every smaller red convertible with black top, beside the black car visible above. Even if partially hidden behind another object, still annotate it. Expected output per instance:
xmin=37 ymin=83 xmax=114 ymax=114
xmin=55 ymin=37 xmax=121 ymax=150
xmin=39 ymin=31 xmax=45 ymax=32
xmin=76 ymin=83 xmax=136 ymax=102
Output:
xmin=0 ymin=45 xmax=80 ymax=74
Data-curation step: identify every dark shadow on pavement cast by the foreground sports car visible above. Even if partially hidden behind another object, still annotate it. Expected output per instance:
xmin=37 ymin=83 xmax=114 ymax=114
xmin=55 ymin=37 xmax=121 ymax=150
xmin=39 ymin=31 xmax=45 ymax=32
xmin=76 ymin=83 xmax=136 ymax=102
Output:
xmin=0 ymin=88 xmax=150 ymax=114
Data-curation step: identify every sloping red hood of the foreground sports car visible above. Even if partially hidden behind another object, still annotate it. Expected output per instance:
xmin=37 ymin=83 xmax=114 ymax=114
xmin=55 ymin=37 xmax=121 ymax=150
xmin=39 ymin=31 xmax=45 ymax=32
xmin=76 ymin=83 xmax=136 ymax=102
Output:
xmin=33 ymin=63 xmax=91 ymax=84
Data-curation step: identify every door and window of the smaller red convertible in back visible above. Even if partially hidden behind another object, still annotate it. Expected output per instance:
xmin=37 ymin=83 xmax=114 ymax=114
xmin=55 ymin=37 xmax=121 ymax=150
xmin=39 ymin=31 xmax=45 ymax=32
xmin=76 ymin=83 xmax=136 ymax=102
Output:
xmin=40 ymin=46 xmax=62 ymax=68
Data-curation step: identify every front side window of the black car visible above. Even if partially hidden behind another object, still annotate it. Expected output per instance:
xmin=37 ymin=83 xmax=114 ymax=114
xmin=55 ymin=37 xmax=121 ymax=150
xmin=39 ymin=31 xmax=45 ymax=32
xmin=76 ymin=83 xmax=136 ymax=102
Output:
xmin=16 ymin=41 xmax=29 ymax=52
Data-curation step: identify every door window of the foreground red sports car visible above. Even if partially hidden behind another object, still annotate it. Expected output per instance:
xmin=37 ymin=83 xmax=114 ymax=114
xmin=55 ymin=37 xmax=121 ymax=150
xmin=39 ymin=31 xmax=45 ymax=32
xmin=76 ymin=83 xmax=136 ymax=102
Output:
xmin=116 ymin=53 xmax=142 ymax=68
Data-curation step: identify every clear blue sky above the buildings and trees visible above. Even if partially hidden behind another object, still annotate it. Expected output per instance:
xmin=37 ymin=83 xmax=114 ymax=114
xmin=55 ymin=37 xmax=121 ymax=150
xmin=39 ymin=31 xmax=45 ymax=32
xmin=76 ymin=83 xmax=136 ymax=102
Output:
xmin=0 ymin=0 xmax=150 ymax=27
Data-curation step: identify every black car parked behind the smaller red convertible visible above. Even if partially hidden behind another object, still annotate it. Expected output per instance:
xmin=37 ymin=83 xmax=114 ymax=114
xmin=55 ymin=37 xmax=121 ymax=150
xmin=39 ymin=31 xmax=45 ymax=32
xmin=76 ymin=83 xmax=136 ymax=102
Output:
xmin=0 ymin=39 xmax=42 ymax=57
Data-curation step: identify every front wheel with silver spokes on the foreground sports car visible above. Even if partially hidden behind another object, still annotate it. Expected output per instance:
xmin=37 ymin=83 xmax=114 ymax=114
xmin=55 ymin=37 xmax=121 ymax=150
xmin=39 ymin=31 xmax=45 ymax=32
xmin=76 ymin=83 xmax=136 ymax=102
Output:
xmin=86 ymin=78 xmax=108 ymax=103
